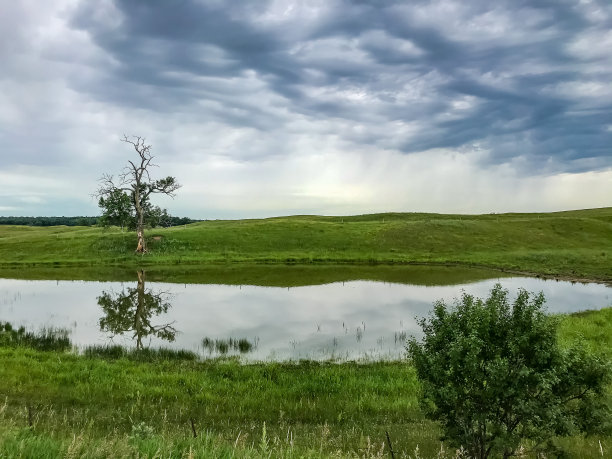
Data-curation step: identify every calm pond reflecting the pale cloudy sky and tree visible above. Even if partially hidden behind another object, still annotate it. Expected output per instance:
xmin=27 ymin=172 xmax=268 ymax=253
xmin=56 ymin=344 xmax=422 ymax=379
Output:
xmin=0 ymin=267 xmax=612 ymax=361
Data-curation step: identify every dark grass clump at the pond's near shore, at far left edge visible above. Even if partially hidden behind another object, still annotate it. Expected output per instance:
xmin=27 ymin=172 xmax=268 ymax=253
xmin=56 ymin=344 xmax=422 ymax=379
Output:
xmin=0 ymin=322 xmax=72 ymax=351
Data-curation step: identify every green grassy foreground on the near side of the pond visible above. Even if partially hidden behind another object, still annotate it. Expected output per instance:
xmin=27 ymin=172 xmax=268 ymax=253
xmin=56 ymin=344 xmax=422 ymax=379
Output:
xmin=0 ymin=309 xmax=612 ymax=458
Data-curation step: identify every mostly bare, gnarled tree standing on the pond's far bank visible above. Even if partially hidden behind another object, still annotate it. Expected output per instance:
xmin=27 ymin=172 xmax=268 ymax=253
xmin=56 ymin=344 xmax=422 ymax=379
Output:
xmin=96 ymin=135 xmax=181 ymax=253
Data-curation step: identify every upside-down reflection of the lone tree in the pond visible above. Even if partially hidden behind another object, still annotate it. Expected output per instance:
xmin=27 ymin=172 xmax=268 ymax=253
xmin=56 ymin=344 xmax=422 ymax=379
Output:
xmin=98 ymin=270 xmax=177 ymax=349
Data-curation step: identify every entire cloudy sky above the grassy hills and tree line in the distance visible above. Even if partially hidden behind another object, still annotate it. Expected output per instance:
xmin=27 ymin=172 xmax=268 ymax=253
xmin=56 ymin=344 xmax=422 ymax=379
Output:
xmin=0 ymin=0 xmax=612 ymax=219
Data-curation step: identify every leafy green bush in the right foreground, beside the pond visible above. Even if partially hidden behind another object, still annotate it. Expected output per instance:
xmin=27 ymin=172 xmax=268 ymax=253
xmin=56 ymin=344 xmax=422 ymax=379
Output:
xmin=407 ymin=284 xmax=610 ymax=459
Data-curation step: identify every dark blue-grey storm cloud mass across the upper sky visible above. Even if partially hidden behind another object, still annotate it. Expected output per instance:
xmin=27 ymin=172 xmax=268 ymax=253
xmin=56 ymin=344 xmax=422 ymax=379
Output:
xmin=0 ymin=0 xmax=592 ymax=177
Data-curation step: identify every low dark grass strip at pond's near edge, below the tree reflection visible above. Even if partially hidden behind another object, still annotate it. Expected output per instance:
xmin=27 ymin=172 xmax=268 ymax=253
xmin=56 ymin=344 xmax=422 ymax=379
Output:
xmin=83 ymin=345 xmax=199 ymax=362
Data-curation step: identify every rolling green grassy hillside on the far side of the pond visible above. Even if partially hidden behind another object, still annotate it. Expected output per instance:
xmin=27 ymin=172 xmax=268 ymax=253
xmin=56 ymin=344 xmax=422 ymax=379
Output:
xmin=0 ymin=208 xmax=612 ymax=281
